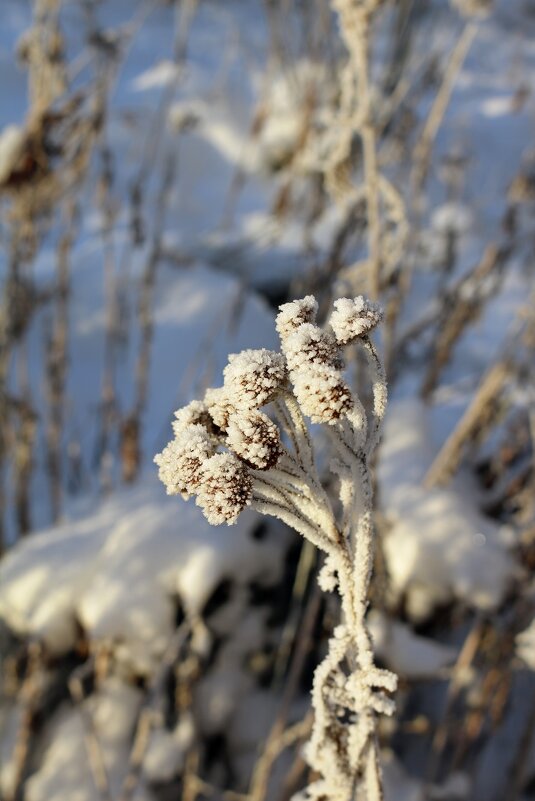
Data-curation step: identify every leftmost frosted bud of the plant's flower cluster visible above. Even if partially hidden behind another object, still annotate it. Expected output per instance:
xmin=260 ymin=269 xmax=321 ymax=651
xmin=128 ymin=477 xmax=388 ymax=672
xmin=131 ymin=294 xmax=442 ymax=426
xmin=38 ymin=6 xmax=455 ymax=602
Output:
xmin=154 ymin=425 xmax=214 ymax=498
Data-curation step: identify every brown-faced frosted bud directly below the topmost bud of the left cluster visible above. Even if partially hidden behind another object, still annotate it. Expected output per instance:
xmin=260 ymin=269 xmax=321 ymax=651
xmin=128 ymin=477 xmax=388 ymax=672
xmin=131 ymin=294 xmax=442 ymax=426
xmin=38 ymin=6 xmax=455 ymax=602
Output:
xmin=227 ymin=410 xmax=282 ymax=470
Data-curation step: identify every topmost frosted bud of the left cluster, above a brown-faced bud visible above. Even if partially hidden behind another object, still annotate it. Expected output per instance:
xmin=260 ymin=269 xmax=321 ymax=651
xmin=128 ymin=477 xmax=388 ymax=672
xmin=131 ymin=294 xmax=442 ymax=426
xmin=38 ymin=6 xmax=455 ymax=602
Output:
xmin=223 ymin=348 xmax=286 ymax=409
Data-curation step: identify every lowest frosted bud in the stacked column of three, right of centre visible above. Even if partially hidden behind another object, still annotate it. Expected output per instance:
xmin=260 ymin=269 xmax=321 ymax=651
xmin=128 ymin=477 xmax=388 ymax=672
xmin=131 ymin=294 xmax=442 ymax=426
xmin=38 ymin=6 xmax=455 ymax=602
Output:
xmin=292 ymin=364 xmax=353 ymax=424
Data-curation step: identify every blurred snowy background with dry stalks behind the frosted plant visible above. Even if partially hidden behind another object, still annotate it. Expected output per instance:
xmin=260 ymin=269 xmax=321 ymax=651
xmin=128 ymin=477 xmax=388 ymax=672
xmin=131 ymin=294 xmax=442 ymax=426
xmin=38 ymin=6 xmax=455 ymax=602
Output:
xmin=0 ymin=0 xmax=535 ymax=801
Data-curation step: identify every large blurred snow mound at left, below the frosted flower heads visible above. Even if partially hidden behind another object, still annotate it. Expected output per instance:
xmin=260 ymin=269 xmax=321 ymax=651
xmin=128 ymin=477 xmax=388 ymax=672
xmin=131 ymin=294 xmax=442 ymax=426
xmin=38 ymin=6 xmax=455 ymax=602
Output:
xmin=0 ymin=480 xmax=281 ymax=673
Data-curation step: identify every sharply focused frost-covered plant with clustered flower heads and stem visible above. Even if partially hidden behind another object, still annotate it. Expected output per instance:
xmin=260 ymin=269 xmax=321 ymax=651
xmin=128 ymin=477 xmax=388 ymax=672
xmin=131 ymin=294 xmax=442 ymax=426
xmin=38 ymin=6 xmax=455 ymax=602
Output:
xmin=155 ymin=295 xmax=397 ymax=801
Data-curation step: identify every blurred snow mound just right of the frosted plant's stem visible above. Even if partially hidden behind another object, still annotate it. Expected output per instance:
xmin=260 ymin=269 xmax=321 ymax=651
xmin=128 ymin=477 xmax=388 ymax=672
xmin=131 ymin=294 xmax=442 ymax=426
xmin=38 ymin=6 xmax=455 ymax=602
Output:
xmin=379 ymin=399 xmax=515 ymax=620
